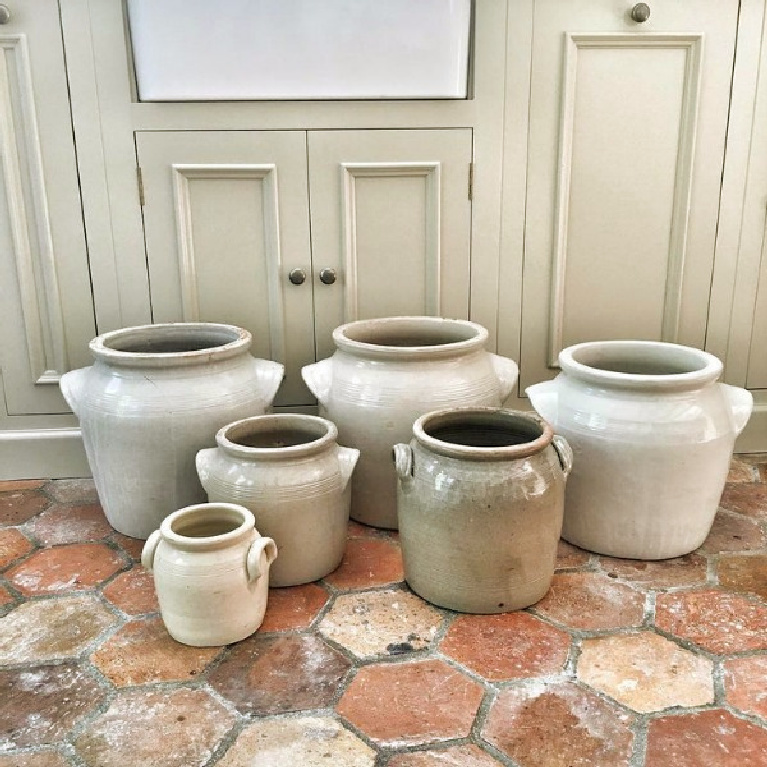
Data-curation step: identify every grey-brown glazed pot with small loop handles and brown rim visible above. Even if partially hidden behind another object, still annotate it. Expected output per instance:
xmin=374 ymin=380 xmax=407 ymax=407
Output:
xmin=394 ymin=408 xmax=572 ymax=613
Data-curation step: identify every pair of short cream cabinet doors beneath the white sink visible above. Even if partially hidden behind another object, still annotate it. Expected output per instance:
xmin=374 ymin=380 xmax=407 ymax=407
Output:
xmin=136 ymin=129 xmax=472 ymax=405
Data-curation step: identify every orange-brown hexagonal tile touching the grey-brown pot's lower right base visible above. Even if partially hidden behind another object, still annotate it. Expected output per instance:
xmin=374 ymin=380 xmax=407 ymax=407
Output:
xmin=534 ymin=573 xmax=644 ymax=630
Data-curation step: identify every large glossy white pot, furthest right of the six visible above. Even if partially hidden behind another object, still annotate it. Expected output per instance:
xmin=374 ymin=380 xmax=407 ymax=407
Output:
xmin=527 ymin=341 xmax=752 ymax=559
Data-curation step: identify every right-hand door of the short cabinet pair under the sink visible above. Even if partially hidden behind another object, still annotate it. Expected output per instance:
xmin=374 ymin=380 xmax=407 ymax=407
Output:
xmin=309 ymin=129 xmax=472 ymax=358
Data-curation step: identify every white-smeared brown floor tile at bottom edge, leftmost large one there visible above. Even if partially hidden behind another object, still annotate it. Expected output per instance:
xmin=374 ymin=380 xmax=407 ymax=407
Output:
xmin=74 ymin=690 xmax=235 ymax=767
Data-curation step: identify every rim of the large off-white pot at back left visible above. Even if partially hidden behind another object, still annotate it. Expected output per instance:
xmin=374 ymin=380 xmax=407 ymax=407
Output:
xmin=89 ymin=322 xmax=252 ymax=368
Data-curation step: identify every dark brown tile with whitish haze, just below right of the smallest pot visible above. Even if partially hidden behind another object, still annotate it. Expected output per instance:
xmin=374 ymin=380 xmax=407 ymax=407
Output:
xmin=208 ymin=635 xmax=351 ymax=715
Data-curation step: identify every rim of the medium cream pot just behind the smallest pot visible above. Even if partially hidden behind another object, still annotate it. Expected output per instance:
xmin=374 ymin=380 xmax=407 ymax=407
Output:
xmin=216 ymin=413 xmax=338 ymax=461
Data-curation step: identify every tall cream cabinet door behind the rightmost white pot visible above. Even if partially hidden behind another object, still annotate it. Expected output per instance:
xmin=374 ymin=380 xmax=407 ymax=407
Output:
xmin=520 ymin=0 xmax=738 ymax=387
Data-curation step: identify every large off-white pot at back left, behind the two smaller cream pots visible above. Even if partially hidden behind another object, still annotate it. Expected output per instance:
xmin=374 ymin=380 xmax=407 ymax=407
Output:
xmin=61 ymin=323 xmax=283 ymax=538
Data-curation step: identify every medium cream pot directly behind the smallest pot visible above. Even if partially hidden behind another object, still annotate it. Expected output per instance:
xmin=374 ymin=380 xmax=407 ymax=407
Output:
xmin=197 ymin=413 xmax=359 ymax=586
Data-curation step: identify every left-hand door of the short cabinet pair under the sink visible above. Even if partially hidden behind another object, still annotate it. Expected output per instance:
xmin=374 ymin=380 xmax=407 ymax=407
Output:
xmin=136 ymin=131 xmax=314 ymax=405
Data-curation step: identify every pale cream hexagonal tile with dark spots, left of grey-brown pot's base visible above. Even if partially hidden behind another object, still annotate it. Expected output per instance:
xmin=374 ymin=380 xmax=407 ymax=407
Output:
xmin=318 ymin=591 xmax=443 ymax=658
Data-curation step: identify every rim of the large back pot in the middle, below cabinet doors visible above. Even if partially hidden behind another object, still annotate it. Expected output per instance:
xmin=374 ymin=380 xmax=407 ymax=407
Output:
xmin=333 ymin=316 xmax=489 ymax=362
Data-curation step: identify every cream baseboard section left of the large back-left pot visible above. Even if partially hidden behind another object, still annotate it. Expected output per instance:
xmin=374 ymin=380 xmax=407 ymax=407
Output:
xmin=0 ymin=427 xmax=91 ymax=479
